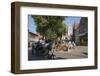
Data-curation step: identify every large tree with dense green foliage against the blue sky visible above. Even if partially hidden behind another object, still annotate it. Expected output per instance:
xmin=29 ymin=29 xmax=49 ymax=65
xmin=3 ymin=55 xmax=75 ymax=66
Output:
xmin=32 ymin=16 xmax=66 ymax=39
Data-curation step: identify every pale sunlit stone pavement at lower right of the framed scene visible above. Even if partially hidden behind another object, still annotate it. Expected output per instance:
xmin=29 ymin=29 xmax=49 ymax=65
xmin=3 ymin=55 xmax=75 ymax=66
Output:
xmin=54 ymin=46 xmax=88 ymax=59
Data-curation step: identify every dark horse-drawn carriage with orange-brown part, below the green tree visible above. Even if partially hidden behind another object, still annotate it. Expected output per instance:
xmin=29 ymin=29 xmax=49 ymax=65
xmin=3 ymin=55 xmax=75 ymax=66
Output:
xmin=32 ymin=41 xmax=76 ymax=59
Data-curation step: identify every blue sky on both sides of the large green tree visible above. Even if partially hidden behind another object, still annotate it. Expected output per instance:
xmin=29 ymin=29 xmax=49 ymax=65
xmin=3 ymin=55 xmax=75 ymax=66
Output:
xmin=28 ymin=15 xmax=81 ymax=33
